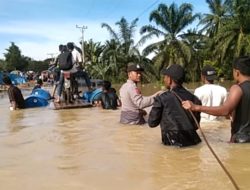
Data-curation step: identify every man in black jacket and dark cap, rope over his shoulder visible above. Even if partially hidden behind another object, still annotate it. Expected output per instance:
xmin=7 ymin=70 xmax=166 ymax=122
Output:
xmin=148 ymin=64 xmax=201 ymax=147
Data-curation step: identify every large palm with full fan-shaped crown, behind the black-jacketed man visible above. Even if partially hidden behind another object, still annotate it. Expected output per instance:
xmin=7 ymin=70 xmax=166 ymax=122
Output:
xmin=140 ymin=3 xmax=199 ymax=78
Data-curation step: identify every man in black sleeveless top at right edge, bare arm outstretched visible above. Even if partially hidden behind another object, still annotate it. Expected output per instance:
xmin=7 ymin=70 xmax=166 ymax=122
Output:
xmin=182 ymin=56 xmax=250 ymax=143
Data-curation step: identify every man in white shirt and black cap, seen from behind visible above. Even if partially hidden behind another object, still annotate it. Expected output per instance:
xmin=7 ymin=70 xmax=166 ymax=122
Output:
xmin=194 ymin=65 xmax=227 ymax=122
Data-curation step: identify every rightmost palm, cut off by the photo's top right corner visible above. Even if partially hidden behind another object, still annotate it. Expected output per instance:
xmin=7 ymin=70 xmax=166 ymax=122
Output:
xmin=212 ymin=0 xmax=250 ymax=62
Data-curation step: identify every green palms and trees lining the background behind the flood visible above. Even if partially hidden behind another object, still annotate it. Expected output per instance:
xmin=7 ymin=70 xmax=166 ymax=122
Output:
xmin=0 ymin=0 xmax=250 ymax=82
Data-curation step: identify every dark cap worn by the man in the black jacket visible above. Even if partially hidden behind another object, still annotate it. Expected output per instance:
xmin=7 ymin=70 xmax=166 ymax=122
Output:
xmin=162 ymin=64 xmax=185 ymax=84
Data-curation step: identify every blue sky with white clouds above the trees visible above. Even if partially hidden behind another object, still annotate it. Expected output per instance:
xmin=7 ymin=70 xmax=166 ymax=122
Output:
xmin=0 ymin=0 xmax=208 ymax=60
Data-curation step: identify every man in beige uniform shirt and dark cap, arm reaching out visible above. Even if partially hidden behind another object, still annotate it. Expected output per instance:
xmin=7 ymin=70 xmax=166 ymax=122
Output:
xmin=120 ymin=63 xmax=162 ymax=125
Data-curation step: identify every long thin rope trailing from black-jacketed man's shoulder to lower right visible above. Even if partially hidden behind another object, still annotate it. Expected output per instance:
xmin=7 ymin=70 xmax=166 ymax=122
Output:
xmin=171 ymin=90 xmax=240 ymax=190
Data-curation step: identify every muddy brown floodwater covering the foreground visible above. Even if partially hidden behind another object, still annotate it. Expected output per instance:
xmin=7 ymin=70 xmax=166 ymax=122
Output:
xmin=0 ymin=84 xmax=250 ymax=190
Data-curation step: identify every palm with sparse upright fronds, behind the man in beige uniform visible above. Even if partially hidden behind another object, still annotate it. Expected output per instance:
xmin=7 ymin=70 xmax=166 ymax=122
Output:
xmin=102 ymin=17 xmax=154 ymax=81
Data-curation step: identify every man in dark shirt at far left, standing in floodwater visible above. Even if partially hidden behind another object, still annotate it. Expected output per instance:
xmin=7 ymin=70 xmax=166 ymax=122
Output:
xmin=3 ymin=76 xmax=24 ymax=110
